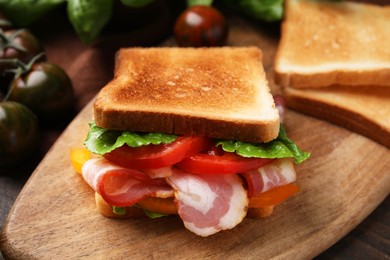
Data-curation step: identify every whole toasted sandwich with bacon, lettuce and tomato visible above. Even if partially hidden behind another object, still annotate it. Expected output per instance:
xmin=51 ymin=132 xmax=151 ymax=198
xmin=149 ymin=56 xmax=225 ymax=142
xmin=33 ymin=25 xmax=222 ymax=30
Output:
xmin=74 ymin=47 xmax=310 ymax=237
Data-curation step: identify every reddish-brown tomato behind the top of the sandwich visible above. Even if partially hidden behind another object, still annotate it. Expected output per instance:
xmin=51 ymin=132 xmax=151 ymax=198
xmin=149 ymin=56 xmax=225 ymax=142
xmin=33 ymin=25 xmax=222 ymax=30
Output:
xmin=174 ymin=5 xmax=228 ymax=47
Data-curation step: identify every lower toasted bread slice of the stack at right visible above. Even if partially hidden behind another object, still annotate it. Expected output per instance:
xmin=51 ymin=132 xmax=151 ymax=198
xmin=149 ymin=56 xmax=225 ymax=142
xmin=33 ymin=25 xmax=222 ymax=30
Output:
xmin=284 ymin=86 xmax=390 ymax=148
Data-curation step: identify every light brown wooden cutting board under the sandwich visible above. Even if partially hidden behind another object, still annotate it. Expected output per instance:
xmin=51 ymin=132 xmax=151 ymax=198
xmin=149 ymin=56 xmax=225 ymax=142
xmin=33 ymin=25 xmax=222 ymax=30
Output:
xmin=0 ymin=17 xmax=390 ymax=259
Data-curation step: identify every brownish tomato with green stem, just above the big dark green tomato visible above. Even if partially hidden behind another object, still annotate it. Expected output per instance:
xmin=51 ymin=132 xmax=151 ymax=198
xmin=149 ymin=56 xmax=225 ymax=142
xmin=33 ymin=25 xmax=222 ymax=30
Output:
xmin=0 ymin=29 xmax=43 ymax=63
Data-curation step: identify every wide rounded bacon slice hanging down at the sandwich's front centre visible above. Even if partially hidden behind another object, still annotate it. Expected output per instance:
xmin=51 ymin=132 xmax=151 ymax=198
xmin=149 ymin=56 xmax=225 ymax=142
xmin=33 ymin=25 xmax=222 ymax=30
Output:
xmin=167 ymin=169 xmax=248 ymax=237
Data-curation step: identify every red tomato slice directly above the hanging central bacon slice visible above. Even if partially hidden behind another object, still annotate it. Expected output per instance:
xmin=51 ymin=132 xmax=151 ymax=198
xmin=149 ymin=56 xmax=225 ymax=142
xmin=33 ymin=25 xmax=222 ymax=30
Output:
xmin=176 ymin=148 xmax=273 ymax=174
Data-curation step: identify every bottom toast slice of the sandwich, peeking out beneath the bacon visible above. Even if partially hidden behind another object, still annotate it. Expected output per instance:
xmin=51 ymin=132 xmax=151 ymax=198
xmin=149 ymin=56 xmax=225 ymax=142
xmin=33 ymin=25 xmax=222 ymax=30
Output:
xmin=95 ymin=192 xmax=274 ymax=219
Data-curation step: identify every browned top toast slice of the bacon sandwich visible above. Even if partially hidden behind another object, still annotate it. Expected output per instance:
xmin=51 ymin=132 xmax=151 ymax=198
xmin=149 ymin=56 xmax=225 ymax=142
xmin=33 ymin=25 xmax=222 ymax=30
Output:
xmin=94 ymin=47 xmax=280 ymax=143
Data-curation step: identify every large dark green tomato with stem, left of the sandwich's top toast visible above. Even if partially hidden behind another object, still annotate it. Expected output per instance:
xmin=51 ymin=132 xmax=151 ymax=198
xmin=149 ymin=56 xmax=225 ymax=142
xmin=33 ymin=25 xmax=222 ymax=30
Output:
xmin=7 ymin=62 xmax=74 ymax=120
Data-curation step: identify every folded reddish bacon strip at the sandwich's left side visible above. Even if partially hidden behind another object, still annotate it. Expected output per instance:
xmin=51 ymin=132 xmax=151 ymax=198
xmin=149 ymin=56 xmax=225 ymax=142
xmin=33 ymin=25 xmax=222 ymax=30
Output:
xmin=82 ymin=158 xmax=173 ymax=207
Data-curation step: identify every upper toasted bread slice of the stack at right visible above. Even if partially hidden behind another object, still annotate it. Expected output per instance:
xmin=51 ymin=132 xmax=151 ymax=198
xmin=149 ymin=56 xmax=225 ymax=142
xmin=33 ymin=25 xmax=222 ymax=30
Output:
xmin=274 ymin=0 xmax=390 ymax=88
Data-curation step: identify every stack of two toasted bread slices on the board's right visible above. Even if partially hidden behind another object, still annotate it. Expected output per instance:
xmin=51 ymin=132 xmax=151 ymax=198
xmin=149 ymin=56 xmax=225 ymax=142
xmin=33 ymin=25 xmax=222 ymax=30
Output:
xmin=274 ymin=0 xmax=390 ymax=147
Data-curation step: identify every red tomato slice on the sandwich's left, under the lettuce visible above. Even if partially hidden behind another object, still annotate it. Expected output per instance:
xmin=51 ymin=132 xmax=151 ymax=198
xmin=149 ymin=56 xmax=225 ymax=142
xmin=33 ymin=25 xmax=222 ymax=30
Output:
xmin=104 ymin=136 xmax=212 ymax=170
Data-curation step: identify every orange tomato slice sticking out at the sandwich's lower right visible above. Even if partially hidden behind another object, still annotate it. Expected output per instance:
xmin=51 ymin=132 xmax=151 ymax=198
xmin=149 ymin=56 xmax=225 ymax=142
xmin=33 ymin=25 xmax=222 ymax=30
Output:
xmin=248 ymin=183 xmax=299 ymax=208
